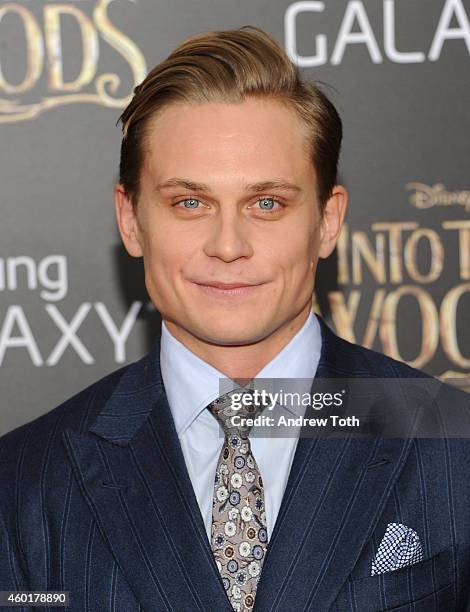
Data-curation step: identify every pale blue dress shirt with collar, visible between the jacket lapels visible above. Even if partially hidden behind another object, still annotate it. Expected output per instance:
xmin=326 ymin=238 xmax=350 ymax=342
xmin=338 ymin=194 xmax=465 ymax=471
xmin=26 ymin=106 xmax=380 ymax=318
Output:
xmin=160 ymin=310 xmax=321 ymax=541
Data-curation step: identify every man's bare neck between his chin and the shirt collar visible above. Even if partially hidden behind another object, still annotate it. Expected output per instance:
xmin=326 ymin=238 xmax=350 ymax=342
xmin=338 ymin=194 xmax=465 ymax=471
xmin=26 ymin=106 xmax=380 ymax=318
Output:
xmin=164 ymin=302 xmax=312 ymax=386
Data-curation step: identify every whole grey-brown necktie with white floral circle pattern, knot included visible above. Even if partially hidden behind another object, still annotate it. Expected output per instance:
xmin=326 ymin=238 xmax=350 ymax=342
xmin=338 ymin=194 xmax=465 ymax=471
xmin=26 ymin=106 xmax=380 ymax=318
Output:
xmin=208 ymin=389 xmax=268 ymax=612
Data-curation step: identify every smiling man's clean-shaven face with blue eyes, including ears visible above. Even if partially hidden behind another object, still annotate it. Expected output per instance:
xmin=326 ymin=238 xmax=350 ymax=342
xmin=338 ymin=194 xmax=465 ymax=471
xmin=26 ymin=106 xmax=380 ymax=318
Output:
xmin=116 ymin=98 xmax=342 ymax=345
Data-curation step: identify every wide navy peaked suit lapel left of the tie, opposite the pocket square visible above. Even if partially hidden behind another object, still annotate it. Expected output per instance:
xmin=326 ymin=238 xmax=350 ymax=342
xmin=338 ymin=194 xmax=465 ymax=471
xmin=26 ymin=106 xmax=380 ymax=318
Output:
xmin=63 ymin=343 xmax=231 ymax=612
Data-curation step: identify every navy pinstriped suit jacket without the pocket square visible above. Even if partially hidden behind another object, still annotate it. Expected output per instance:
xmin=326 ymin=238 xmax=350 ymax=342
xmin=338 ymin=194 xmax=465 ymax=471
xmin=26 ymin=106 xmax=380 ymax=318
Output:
xmin=0 ymin=322 xmax=470 ymax=612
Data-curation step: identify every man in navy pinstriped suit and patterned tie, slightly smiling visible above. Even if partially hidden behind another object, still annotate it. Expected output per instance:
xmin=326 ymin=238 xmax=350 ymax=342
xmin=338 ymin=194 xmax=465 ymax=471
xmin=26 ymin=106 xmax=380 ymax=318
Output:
xmin=0 ymin=27 xmax=470 ymax=612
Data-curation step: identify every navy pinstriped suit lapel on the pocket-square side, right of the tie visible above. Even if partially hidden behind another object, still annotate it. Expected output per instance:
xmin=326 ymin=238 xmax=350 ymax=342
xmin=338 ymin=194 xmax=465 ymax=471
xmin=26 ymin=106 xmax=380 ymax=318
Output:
xmin=255 ymin=322 xmax=412 ymax=612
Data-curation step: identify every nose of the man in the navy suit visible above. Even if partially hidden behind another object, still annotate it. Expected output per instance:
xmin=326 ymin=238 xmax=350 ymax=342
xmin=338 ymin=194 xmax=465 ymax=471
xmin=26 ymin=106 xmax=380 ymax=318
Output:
xmin=204 ymin=208 xmax=253 ymax=263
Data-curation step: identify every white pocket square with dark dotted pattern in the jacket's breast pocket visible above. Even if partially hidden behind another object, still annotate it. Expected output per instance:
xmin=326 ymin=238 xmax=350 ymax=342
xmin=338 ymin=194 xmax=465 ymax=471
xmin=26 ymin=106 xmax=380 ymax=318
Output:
xmin=370 ymin=523 xmax=423 ymax=576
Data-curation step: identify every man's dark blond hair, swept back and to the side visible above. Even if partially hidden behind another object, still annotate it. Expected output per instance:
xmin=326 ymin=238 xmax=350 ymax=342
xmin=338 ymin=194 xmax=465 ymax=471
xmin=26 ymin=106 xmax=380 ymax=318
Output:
xmin=118 ymin=26 xmax=342 ymax=208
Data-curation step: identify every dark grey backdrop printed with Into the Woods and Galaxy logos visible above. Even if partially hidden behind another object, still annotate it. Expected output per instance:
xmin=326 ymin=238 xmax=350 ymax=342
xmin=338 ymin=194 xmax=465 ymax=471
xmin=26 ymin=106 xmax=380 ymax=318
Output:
xmin=0 ymin=0 xmax=470 ymax=434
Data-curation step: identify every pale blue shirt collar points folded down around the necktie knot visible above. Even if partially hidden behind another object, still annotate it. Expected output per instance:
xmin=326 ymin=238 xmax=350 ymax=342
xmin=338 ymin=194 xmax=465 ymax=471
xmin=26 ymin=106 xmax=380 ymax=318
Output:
xmin=160 ymin=310 xmax=321 ymax=436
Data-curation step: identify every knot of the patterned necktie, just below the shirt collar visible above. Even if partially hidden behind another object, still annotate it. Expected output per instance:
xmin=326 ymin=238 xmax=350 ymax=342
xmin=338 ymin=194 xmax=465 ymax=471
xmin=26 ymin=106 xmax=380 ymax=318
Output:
xmin=207 ymin=389 xmax=264 ymax=435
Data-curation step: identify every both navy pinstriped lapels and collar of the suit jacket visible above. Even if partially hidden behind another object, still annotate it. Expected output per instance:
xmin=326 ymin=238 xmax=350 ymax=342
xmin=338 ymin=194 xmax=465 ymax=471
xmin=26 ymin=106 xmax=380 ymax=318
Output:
xmin=64 ymin=320 xmax=411 ymax=612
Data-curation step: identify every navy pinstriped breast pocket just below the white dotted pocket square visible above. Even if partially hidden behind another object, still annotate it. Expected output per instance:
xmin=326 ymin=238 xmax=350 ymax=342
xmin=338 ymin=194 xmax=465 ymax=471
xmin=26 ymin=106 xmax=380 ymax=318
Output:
xmin=336 ymin=547 xmax=455 ymax=612
